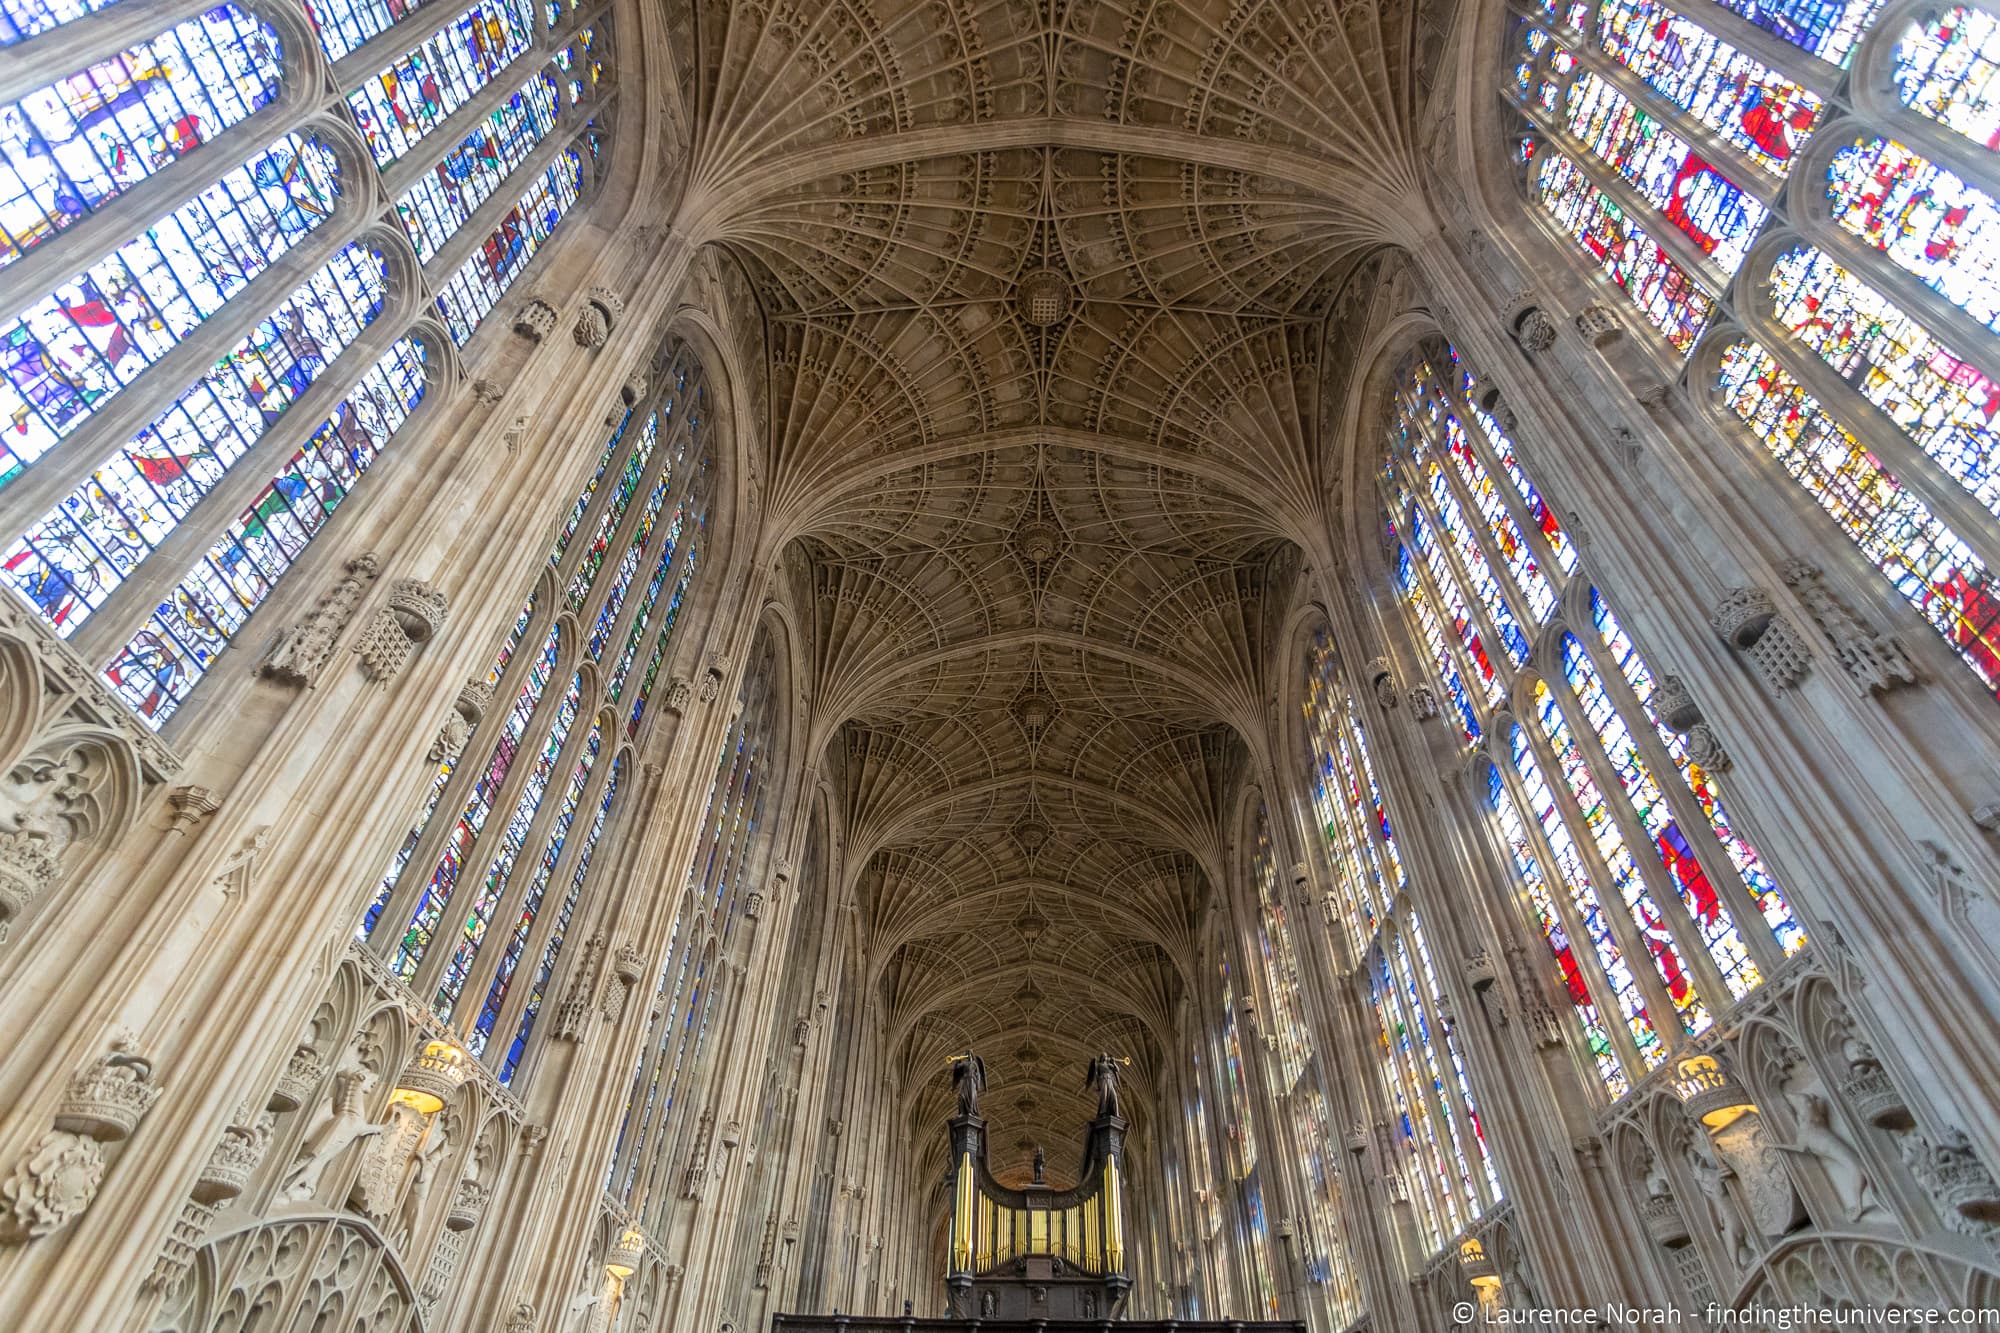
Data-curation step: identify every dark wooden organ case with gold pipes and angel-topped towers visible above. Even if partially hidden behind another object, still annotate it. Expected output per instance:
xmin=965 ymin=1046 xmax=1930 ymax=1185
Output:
xmin=944 ymin=1053 xmax=1132 ymax=1321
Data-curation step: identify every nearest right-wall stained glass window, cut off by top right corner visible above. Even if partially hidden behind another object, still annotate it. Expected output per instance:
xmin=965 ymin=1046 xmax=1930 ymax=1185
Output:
xmin=1506 ymin=0 xmax=2000 ymax=691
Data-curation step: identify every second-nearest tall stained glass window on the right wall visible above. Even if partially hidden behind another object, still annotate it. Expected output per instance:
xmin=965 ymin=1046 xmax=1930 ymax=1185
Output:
xmin=1382 ymin=344 xmax=1804 ymax=1099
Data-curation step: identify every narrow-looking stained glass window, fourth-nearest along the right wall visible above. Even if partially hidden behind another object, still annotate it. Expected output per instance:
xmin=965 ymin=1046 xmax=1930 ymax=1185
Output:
xmin=1250 ymin=803 xmax=1362 ymax=1327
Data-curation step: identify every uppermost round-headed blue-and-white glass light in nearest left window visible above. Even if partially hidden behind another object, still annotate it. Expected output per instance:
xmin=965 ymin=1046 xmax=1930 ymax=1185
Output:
xmin=0 ymin=0 xmax=284 ymax=266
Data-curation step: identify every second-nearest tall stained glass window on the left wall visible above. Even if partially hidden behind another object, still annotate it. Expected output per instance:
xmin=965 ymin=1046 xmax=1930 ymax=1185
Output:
xmin=358 ymin=342 xmax=706 ymax=1083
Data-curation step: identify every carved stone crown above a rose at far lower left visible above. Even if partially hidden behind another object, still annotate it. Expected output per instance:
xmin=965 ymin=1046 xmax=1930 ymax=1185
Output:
xmin=0 ymin=1039 xmax=160 ymax=1245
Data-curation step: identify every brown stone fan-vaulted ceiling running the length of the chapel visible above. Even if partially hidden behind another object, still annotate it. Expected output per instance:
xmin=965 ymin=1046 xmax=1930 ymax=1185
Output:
xmin=670 ymin=0 xmax=1444 ymax=1175
